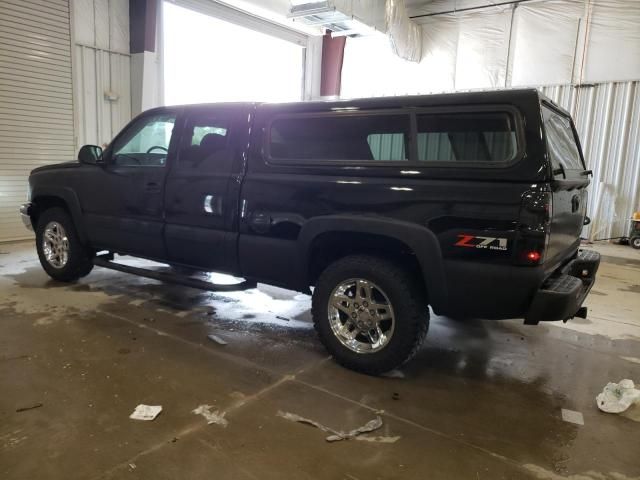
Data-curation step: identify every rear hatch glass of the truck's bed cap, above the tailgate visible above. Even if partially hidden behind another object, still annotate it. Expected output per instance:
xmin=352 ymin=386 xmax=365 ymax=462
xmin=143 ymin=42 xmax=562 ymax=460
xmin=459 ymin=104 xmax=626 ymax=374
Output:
xmin=542 ymin=105 xmax=584 ymax=170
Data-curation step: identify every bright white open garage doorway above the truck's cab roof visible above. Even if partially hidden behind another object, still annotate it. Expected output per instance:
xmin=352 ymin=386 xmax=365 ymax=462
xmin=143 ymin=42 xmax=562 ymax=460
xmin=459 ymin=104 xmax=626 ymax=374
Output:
xmin=163 ymin=2 xmax=304 ymax=105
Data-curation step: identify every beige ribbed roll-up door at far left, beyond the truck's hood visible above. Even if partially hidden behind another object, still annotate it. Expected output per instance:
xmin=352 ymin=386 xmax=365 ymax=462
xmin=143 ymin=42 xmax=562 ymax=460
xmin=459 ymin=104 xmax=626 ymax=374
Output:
xmin=0 ymin=0 xmax=74 ymax=241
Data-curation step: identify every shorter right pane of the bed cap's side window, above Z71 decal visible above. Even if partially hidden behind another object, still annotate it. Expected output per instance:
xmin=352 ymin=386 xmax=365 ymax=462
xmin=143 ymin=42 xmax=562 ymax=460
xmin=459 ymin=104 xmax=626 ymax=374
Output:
xmin=417 ymin=112 xmax=518 ymax=163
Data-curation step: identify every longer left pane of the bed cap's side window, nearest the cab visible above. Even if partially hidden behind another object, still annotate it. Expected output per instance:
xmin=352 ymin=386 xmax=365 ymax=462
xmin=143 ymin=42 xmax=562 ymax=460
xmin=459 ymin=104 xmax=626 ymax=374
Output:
xmin=270 ymin=114 xmax=410 ymax=161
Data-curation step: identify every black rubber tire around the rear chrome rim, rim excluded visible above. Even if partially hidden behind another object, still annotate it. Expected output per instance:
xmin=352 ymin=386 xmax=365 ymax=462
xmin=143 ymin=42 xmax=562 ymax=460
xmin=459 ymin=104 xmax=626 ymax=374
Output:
xmin=311 ymin=255 xmax=429 ymax=375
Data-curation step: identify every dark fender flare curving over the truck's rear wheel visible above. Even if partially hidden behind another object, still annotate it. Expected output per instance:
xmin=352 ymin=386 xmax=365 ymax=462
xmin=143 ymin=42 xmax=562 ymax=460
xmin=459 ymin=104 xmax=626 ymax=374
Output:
xmin=298 ymin=215 xmax=447 ymax=310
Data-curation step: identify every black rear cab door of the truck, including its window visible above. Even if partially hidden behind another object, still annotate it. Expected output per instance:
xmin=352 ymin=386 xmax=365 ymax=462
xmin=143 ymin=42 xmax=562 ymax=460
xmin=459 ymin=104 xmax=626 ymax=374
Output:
xmin=165 ymin=107 xmax=249 ymax=273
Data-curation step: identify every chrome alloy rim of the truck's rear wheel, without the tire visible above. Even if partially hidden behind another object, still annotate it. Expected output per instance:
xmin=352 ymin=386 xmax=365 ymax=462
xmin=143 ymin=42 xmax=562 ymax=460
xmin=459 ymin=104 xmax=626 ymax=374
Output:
xmin=327 ymin=278 xmax=395 ymax=353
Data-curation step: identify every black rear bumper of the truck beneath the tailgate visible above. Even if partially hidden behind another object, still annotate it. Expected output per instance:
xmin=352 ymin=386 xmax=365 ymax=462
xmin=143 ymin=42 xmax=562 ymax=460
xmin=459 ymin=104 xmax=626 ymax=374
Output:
xmin=524 ymin=250 xmax=600 ymax=325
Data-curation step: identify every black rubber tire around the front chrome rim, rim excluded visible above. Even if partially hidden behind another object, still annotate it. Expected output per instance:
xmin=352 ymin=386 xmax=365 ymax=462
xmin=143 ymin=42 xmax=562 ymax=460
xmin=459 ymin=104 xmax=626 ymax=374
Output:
xmin=36 ymin=207 xmax=93 ymax=282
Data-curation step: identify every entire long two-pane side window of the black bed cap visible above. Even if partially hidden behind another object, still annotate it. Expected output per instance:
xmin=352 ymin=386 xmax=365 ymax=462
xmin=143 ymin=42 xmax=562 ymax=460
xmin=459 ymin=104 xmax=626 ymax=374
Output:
xmin=268 ymin=109 xmax=522 ymax=167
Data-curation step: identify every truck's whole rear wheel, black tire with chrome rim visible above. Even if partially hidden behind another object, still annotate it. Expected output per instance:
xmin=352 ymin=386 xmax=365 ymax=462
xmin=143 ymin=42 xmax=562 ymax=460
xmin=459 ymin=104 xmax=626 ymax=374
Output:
xmin=312 ymin=255 xmax=429 ymax=375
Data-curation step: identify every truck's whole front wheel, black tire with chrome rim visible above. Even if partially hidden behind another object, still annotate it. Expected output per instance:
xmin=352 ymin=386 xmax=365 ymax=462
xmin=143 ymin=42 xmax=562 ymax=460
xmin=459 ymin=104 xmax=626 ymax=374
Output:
xmin=36 ymin=207 xmax=93 ymax=282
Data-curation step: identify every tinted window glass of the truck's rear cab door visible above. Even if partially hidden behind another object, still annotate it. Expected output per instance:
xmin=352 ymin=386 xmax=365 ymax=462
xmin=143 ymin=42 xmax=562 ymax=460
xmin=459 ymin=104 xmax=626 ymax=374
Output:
xmin=178 ymin=115 xmax=231 ymax=171
